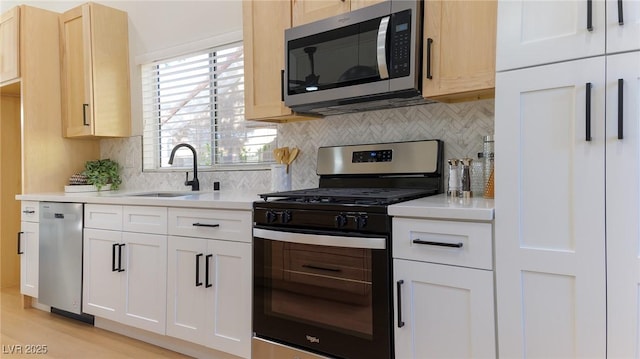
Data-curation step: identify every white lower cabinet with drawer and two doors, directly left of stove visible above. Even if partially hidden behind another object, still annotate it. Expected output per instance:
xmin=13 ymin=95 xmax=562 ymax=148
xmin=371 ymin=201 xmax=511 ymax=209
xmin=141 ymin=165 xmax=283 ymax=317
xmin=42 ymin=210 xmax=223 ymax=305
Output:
xmin=167 ymin=209 xmax=252 ymax=358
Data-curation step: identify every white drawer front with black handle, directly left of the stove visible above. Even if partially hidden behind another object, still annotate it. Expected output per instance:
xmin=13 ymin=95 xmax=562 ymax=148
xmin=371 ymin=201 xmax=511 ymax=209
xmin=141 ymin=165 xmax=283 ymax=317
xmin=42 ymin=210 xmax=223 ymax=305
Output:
xmin=169 ymin=208 xmax=252 ymax=243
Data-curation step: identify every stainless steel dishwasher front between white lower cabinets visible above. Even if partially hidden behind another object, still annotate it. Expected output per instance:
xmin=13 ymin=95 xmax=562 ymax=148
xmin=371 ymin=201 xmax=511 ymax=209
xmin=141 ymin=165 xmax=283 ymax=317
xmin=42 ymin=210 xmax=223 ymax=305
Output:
xmin=38 ymin=202 xmax=84 ymax=315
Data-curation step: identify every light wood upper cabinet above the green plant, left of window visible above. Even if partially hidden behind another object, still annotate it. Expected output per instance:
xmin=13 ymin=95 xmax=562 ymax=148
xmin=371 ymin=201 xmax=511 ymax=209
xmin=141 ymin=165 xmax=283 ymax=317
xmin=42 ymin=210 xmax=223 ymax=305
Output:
xmin=60 ymin=3 xmax=131 ymax=137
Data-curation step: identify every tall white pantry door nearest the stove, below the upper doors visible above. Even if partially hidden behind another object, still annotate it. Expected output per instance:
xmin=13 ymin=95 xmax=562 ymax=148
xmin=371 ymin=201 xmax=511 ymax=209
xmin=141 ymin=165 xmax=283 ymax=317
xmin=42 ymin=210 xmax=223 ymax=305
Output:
xmin=495 ymin=57 xmax=606 ymax=358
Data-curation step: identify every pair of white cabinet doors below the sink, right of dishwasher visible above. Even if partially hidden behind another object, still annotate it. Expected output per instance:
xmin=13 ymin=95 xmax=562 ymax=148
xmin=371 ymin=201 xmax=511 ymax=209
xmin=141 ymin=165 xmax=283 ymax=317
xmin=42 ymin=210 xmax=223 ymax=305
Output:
xmin=83 ymin=229 xmax=167 ymax=334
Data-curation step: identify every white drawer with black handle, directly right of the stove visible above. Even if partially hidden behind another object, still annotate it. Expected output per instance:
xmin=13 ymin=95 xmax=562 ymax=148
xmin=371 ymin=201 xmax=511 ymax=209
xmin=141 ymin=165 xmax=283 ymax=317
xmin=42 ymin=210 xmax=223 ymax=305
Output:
xmin=393 ymin=217 xmax=493 ymax=270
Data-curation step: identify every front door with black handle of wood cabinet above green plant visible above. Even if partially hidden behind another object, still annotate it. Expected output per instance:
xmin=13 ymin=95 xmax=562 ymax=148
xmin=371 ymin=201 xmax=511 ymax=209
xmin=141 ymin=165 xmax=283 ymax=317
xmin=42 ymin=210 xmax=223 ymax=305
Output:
xmin=60 ymin=6 xmax=93 ymax=137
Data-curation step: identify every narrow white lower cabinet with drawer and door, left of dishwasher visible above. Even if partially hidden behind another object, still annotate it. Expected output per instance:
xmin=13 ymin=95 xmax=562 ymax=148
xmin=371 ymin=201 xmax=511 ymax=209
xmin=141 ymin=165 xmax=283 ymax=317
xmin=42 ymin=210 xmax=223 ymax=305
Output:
xmin=18 ymin=201 xmax=40 ymax=298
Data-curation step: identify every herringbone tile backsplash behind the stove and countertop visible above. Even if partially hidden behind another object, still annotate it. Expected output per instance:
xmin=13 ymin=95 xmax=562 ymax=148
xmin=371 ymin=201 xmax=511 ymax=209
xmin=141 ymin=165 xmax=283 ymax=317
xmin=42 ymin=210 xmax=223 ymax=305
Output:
xmin=100 ymin=100 xmax=494 ymax=191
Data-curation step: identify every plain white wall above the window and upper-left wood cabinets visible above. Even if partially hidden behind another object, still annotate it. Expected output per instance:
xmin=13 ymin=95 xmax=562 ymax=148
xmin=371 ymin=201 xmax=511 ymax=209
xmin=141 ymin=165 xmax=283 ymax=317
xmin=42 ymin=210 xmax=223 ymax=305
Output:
xmin=0 ymin=0 xmax=242 ymax=134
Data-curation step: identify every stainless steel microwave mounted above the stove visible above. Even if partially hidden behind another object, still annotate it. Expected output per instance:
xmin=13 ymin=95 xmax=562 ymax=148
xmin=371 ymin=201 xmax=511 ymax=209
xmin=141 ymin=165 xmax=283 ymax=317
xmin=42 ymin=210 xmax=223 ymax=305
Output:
xmin=283 ymin=0 xmax=424 ymax=115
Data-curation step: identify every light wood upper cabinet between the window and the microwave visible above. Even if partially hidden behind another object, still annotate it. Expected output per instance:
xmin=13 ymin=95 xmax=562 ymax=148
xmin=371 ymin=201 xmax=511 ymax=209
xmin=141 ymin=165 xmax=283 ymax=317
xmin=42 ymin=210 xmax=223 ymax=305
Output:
xmin=242 ymin=1 xmax=314 ymax=122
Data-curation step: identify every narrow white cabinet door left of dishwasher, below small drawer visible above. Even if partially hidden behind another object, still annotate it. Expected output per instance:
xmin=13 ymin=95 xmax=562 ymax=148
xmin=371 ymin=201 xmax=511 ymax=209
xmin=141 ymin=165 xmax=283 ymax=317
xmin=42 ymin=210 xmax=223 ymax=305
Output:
xmin=18 ymin=222 xmax=40 ymax=298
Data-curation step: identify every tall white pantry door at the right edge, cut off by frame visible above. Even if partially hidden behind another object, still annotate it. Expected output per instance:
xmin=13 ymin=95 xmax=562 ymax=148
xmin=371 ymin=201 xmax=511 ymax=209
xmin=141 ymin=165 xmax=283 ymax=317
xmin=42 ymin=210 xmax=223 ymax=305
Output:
xmin=606 ymin=51 xmax=640 ymax=358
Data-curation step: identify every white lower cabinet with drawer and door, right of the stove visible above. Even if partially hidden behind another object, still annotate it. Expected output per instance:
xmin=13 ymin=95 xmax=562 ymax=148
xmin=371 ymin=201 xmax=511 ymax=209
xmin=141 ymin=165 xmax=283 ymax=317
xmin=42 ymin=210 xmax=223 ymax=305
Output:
xmin=393 ymin=218 xmax=496 ymax=359
